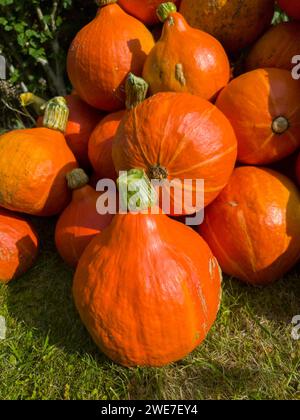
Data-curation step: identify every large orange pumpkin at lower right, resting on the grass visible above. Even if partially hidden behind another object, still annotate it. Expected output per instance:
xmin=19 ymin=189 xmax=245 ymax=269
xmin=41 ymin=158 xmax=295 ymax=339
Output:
xmin=200 ymin=167 xmax=300 ymax=285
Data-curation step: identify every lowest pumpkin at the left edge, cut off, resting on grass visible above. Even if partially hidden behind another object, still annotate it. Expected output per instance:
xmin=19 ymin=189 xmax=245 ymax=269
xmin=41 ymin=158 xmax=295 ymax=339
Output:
xmin=0 ymin=209 xmax=38 ymax=283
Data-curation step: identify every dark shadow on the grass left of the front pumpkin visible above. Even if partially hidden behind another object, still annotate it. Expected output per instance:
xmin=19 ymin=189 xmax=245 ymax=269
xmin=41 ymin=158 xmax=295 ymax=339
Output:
xmin=7 ymin=218 xmax=106 ymax=362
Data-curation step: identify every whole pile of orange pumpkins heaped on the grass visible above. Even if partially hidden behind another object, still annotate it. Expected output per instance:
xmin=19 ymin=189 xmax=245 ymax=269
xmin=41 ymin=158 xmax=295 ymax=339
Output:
xmin=0 ymin=0 xmax=300 ymax=366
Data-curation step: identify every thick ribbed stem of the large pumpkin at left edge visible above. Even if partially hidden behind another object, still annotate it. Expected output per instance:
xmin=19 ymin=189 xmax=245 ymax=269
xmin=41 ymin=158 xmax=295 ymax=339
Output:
xmin=43 ymin=96 xmax=69 ymax=133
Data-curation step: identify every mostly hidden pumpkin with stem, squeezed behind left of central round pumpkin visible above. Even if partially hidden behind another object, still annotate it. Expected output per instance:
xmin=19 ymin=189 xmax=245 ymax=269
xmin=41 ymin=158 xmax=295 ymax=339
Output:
xmin=88 ymin=73 xmax=148 ymax=180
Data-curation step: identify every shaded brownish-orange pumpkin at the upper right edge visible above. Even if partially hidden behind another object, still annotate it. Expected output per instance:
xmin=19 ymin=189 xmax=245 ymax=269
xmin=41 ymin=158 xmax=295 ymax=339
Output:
xmin=245 ymin=22 xmax=300 ymax=71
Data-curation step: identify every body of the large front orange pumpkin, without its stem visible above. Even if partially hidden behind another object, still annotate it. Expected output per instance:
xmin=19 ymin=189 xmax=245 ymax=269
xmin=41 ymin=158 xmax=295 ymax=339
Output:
xmin=73 ymin=214 xmax=221 ymax=366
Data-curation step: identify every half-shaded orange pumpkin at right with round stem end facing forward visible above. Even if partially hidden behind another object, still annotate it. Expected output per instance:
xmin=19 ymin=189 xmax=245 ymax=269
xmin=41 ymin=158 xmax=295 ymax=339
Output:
xmin=216 ymin=69 xmax=300 ymax=165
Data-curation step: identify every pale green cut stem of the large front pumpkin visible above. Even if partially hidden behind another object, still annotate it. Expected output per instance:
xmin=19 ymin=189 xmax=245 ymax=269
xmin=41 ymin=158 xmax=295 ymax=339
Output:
xmin=117 ymin=169 xmax=158 ymax=212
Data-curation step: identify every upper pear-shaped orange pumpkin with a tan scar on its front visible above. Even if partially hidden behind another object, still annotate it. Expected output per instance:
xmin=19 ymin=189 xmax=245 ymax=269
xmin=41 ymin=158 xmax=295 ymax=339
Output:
xmin=143 ymin=13 xmax=230 ymax=100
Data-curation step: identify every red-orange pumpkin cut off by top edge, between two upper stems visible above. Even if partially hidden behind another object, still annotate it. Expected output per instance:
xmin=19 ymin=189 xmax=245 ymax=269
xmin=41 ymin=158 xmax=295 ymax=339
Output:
xmin=118 ymin=0 xmax=180 ymax=25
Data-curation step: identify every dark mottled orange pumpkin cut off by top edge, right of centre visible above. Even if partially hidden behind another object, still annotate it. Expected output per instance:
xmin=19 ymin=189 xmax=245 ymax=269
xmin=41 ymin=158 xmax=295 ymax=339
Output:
xmin=180 ymin=0 xmax=274 ymax=53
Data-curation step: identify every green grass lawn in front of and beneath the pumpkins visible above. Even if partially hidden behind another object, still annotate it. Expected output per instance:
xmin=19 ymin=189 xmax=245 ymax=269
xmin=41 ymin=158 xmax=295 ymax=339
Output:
xmin=0 ymin=220 xmax=300 ymax=400
